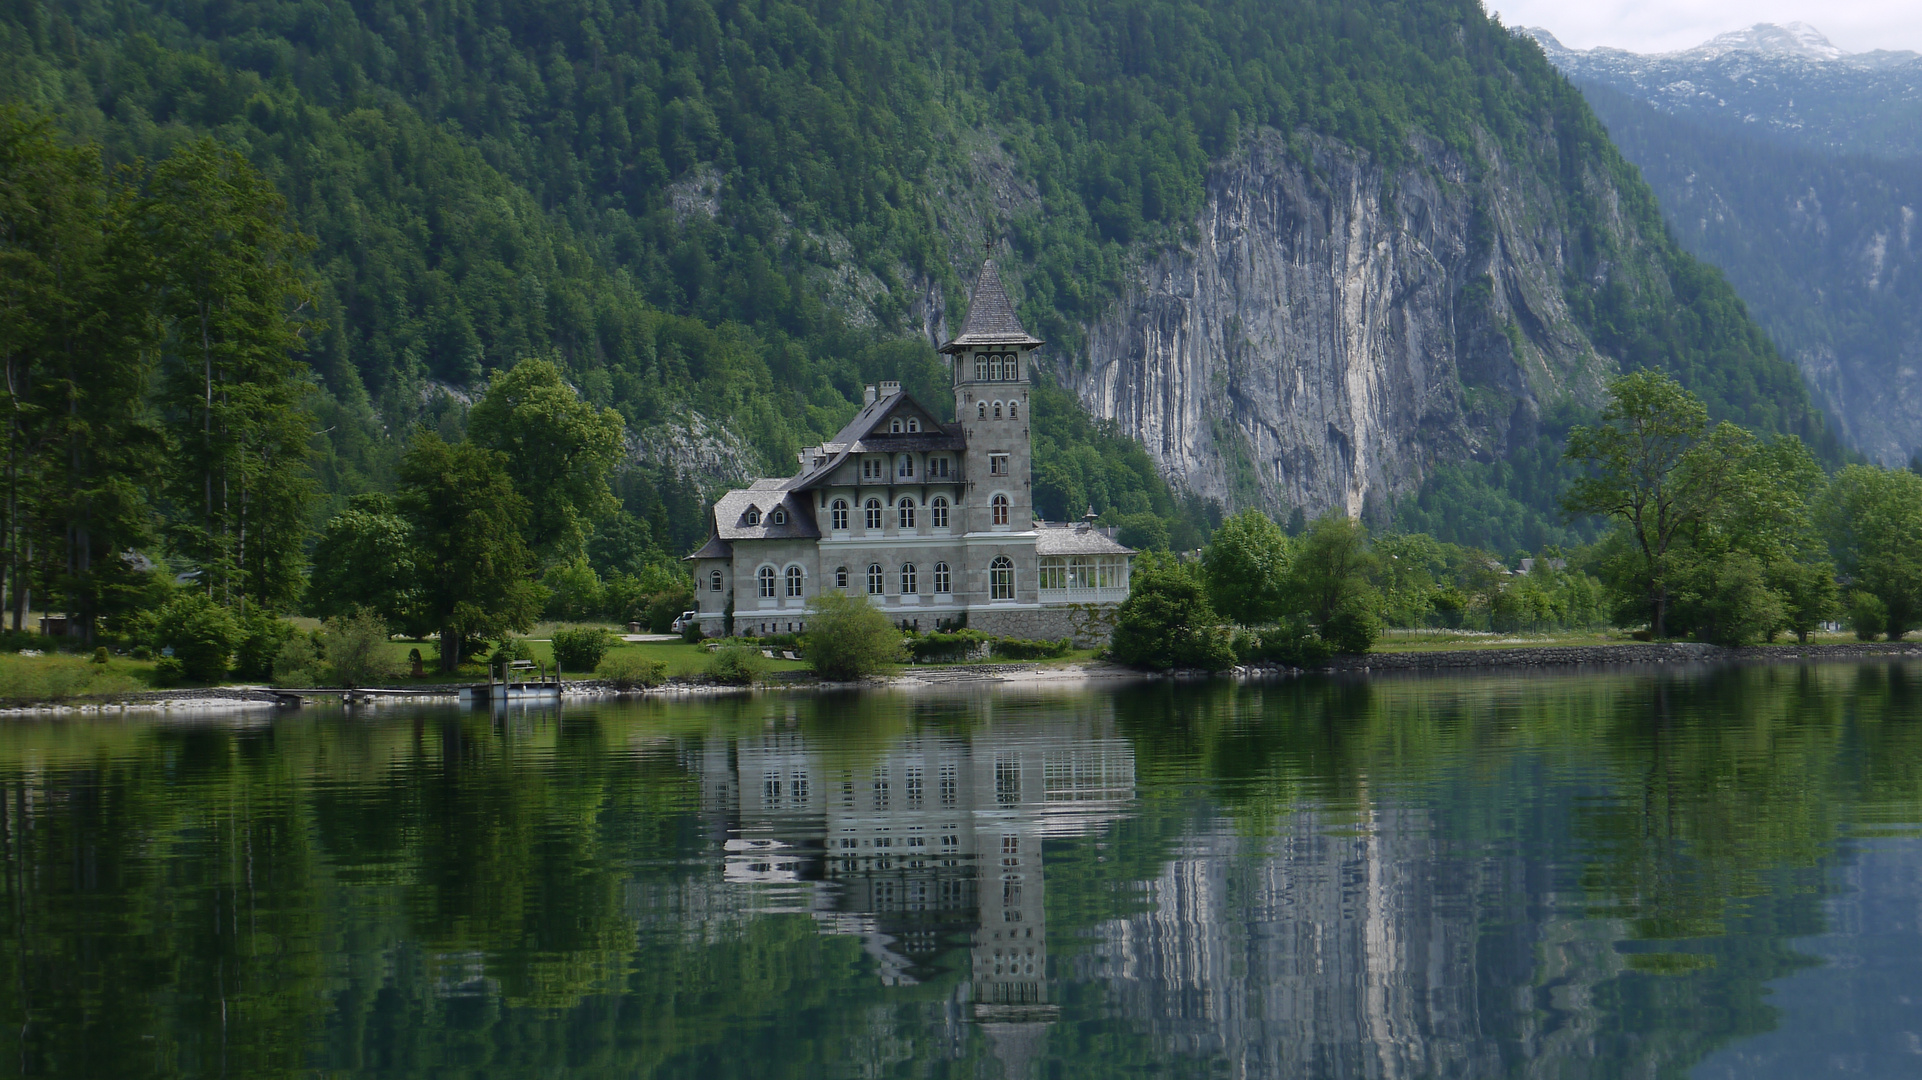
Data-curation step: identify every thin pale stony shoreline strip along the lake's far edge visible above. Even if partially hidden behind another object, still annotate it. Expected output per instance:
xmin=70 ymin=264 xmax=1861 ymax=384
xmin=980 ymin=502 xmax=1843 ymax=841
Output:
xmin=11 ymin=642 xmax=1922 ymax=719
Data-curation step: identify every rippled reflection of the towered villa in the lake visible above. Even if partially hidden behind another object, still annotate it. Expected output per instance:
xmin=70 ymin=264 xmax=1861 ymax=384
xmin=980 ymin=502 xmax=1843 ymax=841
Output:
xmin=688 ymin=699 xmax=1134 ymax=1076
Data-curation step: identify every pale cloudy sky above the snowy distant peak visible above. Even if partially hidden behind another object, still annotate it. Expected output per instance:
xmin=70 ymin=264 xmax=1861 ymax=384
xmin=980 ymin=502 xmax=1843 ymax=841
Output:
xmin=1484 ymin=0 xmax=1922 ymax=52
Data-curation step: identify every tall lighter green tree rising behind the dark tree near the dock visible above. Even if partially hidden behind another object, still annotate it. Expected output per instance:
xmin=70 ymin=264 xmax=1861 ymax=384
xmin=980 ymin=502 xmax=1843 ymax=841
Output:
xmin=467 ymin=359 xmax=623 ymax=559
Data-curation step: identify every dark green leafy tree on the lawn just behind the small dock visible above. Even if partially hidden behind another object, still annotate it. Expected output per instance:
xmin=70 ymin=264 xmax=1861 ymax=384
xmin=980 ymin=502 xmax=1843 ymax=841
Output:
xmin=400 ymin=430 xmax=542 ymax=673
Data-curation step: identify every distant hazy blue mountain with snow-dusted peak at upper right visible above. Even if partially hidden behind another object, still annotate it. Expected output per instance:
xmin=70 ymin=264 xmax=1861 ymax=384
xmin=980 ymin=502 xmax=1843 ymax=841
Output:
xmin=1528 ymin=23 xmax=1922 ymax=463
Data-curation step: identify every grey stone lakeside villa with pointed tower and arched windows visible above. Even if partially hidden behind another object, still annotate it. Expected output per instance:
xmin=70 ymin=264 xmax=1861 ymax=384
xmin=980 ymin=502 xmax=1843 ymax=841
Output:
xmin=688 ymin=261 xmax=1132 ymax=644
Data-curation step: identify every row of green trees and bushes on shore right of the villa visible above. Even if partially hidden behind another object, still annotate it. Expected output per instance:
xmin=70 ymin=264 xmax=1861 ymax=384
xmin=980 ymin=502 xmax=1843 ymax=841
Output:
xmin=1113 ymin=369 xmax=1922 ymax=669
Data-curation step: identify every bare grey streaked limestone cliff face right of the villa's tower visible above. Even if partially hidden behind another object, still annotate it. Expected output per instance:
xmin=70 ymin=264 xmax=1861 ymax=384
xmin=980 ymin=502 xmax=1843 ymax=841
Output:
xmin=1055 ymin=133 xmax=1614 ymax=515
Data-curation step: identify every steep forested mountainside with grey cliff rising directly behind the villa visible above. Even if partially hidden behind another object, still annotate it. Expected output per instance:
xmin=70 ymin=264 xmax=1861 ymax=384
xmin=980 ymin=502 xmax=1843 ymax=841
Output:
xmin=0 ymin=0 xmax=1834 ymax=546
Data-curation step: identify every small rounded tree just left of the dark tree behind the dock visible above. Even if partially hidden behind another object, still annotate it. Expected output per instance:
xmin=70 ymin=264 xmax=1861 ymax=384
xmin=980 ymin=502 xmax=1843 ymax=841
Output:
xmin=308 ymin=494 xmax=432 ymax=634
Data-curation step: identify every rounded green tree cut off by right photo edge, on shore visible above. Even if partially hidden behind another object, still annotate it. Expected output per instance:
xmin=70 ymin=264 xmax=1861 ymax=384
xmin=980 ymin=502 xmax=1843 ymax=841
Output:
xmin=1820 ymin=465 xmax=1922 ymax=642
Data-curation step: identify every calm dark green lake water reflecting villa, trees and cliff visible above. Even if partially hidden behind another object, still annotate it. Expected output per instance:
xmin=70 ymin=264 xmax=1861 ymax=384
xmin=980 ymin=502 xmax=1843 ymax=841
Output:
xmin=0 ymin=663 xmax=1922 ymax=1080
